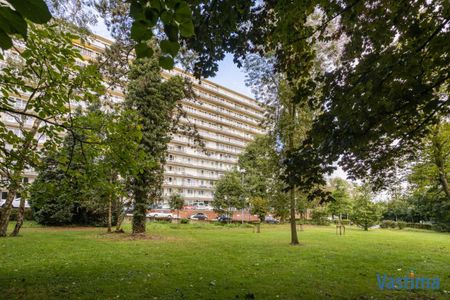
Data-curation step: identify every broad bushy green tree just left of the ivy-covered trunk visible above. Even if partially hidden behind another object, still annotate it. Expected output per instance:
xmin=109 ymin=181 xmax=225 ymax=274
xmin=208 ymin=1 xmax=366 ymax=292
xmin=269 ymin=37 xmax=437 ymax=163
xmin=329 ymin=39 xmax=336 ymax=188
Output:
xmin=30 ymin=103 xmax=141 ymax=232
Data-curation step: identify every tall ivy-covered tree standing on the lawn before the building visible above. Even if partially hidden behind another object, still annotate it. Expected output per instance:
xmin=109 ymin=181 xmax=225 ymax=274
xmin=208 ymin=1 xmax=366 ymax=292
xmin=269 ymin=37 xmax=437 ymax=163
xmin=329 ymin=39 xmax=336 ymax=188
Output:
xmin=125 ymin=58 xmax=191 ymax=234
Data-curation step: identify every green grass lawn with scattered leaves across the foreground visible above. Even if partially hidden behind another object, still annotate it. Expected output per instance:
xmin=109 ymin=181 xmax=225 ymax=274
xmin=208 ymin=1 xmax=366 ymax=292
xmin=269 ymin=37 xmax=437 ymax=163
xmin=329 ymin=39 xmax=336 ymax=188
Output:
xmin=0 ymin=223 xmax=450 ymax=299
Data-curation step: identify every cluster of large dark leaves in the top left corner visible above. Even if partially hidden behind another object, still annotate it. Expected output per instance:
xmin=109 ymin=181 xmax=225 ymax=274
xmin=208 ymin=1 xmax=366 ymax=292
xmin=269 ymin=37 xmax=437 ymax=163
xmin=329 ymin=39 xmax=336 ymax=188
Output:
xmin=0 ymin=0 xmax=52 ymax=50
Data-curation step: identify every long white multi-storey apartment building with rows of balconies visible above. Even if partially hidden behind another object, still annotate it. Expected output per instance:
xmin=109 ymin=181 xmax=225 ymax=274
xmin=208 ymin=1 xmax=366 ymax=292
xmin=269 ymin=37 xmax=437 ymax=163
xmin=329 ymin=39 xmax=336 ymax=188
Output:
xmin=1 ymin=36 xmax=264 ymax=205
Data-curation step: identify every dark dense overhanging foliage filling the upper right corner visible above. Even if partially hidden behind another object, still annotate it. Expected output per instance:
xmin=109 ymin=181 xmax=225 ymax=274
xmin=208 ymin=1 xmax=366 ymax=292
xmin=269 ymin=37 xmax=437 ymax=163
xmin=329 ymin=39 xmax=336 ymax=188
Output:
xmin=311 ymin=0 xmax=450 ymax=187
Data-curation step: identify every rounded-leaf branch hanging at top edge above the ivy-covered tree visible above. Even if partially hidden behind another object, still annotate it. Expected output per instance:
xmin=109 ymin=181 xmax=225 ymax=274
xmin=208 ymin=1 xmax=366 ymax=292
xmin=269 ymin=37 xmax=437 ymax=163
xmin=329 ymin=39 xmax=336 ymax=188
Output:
xmin=130 ymin=0 xmax=194 ymax=69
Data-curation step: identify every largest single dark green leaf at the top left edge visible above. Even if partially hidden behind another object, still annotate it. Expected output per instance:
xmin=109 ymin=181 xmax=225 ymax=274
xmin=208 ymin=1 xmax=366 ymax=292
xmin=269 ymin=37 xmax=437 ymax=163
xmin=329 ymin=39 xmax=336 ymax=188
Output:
xmin=8 ymin=0 xmax=52 ymax=24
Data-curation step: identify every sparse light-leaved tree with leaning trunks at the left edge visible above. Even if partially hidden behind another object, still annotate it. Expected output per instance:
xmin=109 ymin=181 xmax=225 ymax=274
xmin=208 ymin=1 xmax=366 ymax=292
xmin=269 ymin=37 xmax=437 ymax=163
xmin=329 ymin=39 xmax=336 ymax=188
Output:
xmin=0 ymin=24 xmax=103 ymax=236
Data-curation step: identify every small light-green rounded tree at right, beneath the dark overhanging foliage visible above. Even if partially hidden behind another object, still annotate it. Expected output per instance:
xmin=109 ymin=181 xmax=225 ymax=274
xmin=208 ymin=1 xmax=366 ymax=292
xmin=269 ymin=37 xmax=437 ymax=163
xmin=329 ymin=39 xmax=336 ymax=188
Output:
xmin=350 ymin=184 xmax=381 ymax=231
